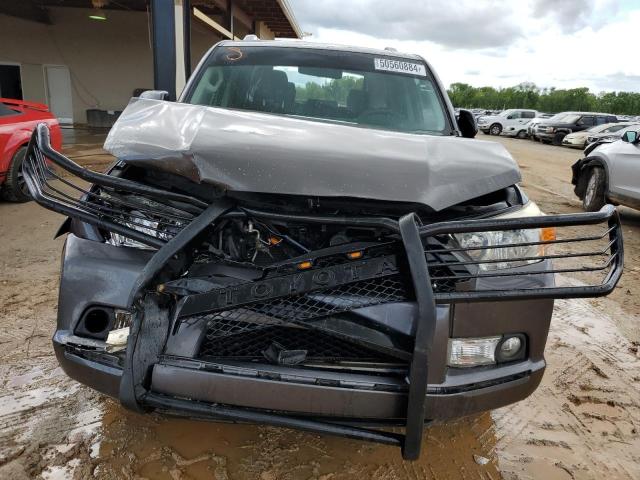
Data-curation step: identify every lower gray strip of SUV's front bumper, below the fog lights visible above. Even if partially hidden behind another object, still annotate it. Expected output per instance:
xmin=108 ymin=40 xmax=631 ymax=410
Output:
xmin=53 ymin=326 xmax=548 ymax=425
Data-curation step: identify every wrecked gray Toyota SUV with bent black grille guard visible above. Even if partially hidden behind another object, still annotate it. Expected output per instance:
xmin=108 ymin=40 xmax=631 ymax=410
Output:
xmin=24 ymin=41 xmax=623 ymax=459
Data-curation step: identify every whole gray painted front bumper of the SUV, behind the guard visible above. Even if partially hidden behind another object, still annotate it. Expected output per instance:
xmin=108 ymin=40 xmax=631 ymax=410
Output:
xmin=53 ymin=234 xmax=553 ymax=416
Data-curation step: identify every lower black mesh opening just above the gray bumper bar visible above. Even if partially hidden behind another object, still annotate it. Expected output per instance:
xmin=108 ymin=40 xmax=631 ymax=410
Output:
xmin=199 ymin=322 xmax=397 ymax=362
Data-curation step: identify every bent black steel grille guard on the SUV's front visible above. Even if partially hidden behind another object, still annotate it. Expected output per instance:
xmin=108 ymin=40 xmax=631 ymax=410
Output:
xmin=25 ymin=125 xmax=623 ymax=459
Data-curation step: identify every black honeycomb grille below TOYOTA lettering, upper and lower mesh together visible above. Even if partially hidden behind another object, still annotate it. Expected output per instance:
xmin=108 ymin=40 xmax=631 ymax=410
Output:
xmin=195 ymin=275 xmax=412 ymax=362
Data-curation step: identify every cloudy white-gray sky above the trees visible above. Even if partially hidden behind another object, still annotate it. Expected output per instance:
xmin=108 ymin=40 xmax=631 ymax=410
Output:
xmin=289 ymin=0 xmax=640 ymax=93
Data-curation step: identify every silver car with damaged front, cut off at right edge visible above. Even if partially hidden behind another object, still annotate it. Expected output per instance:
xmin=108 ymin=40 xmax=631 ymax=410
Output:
xmin=571 ymin=126 xmax=640 ymax=212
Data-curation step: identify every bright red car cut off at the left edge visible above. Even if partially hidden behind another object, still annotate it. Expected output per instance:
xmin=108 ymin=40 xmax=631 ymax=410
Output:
xmin=0 ymin=98 xmax=62 ymax=202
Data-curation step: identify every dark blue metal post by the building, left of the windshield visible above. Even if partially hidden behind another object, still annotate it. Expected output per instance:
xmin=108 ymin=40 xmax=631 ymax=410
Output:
xmin=151 ymin=0 xmax=176 ymax=100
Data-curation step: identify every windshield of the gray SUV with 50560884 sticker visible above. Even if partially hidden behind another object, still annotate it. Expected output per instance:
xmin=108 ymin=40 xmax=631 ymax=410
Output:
xmin=185 ymin=46 xmax=451 ymax=135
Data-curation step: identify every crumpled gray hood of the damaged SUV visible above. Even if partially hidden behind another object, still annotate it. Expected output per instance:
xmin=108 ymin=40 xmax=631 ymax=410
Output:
xmin=104 ymin=99 xmax=520 ymax=211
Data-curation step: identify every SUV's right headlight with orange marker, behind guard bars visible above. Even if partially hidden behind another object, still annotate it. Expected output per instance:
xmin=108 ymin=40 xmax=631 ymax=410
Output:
xmin=454 ymin=202 xmax=555 ymax=271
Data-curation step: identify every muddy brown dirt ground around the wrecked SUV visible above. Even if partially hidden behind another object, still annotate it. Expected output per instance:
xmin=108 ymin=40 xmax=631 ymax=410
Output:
xmin=0 ymin=129 xmax=640 ymax=480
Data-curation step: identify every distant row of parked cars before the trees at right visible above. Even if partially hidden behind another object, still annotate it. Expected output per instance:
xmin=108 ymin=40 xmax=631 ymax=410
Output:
xmin=476 ymin=109 xmax=640 ymax=149
